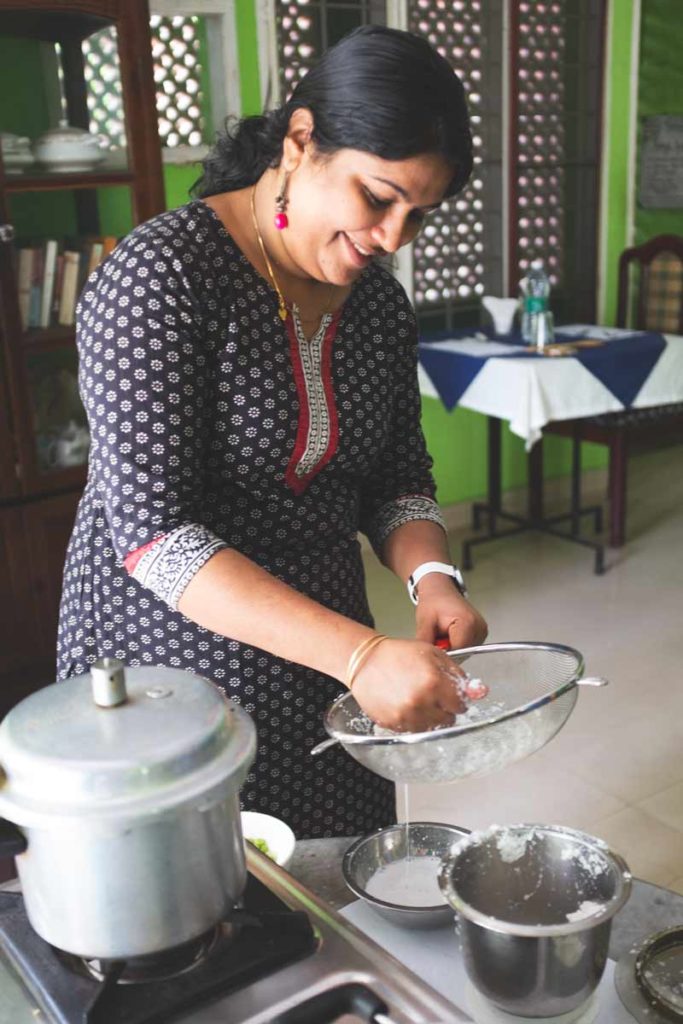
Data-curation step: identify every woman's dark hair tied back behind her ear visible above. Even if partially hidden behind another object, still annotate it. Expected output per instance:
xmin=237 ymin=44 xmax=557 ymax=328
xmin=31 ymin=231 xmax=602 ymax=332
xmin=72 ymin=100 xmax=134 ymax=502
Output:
xmin=193 ymin=26 xmax=472 ymax=198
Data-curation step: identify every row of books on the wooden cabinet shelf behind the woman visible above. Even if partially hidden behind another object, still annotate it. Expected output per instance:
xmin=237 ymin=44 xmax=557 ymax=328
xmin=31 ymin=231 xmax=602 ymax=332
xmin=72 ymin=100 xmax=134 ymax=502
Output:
xmin=16 ymin=234 xmax=118 ymax=331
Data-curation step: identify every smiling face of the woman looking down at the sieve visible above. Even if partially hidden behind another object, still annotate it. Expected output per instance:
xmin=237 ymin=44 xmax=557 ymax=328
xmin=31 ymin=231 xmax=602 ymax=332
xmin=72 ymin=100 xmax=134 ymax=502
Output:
xmin=279 ymin=143 xmax=453 ymax=286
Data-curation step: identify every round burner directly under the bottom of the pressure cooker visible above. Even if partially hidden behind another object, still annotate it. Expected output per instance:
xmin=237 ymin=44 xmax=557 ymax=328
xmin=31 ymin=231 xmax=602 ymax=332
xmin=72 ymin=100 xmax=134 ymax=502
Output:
xmin=64 ymin=921 xmax=225 ymax=985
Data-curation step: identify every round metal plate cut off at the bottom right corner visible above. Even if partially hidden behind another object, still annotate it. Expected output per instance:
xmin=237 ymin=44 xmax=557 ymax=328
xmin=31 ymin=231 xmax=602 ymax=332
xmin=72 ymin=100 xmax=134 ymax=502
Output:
xmin=614 ymin=927 xmax=683 ymax=1024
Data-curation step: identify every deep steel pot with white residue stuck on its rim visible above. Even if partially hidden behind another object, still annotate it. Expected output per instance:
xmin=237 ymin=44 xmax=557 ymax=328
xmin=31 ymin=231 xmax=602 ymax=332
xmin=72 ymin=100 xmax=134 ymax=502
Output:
xmin=439 ymin=825 xmax=631 ymax=1017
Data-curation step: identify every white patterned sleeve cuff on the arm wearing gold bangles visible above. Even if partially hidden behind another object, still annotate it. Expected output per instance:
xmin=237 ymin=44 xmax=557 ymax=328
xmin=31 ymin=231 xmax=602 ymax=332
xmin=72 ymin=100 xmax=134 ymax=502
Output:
xmin=131 ymin=522 xmax=227 ymax=608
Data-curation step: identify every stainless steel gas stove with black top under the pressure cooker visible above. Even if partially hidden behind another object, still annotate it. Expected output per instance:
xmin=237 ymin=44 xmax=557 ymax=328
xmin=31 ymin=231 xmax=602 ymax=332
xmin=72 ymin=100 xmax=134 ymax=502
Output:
xmin=0 ymin=848 xmax=469 ymax=1024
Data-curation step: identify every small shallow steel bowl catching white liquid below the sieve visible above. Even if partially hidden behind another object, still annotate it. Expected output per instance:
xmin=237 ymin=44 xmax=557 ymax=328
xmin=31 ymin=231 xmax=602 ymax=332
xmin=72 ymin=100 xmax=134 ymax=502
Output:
xmin=342 ymin=821 xmax=469 ymax=928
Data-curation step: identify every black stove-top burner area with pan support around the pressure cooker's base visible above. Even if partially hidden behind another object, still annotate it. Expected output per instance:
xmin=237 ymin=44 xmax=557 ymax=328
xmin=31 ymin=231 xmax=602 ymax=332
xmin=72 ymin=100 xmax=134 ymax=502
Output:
xmin=0 ymin=874 xmax=317 ymax=1024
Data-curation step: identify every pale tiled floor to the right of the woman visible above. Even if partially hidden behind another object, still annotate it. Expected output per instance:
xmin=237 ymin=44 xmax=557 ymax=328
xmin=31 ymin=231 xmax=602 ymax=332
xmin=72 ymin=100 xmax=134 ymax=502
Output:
xmin=366 ymin=446 xmax=683 ymax=893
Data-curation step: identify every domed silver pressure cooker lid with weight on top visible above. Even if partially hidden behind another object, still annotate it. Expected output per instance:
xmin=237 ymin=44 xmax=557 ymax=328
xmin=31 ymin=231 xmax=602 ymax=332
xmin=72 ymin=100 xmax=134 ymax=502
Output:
xmin=0 ymin=658 xmax=256 ymax=824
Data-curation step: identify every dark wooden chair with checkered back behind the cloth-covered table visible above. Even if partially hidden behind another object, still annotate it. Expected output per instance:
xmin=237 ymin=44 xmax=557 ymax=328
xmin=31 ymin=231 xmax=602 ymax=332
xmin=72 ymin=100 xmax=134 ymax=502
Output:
xmin=546 ymin=234 xmax=683 ymax=548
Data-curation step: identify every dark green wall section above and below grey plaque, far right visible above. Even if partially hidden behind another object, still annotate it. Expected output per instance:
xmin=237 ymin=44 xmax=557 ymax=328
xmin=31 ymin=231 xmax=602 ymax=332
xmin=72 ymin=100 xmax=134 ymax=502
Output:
xmin=634 ymin=0 xmax=683 ymax=244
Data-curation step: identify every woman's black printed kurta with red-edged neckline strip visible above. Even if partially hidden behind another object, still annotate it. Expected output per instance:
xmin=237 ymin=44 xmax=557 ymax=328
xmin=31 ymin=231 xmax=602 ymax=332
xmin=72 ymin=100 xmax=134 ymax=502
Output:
xmin=58 ymin=202 xmax=440 ymax=838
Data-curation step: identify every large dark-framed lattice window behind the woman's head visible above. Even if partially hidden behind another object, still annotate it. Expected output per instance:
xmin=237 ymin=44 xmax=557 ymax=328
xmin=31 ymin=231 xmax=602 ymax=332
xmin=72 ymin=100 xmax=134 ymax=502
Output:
xmin=274 ymin=0 xmax=605 ymax=329
